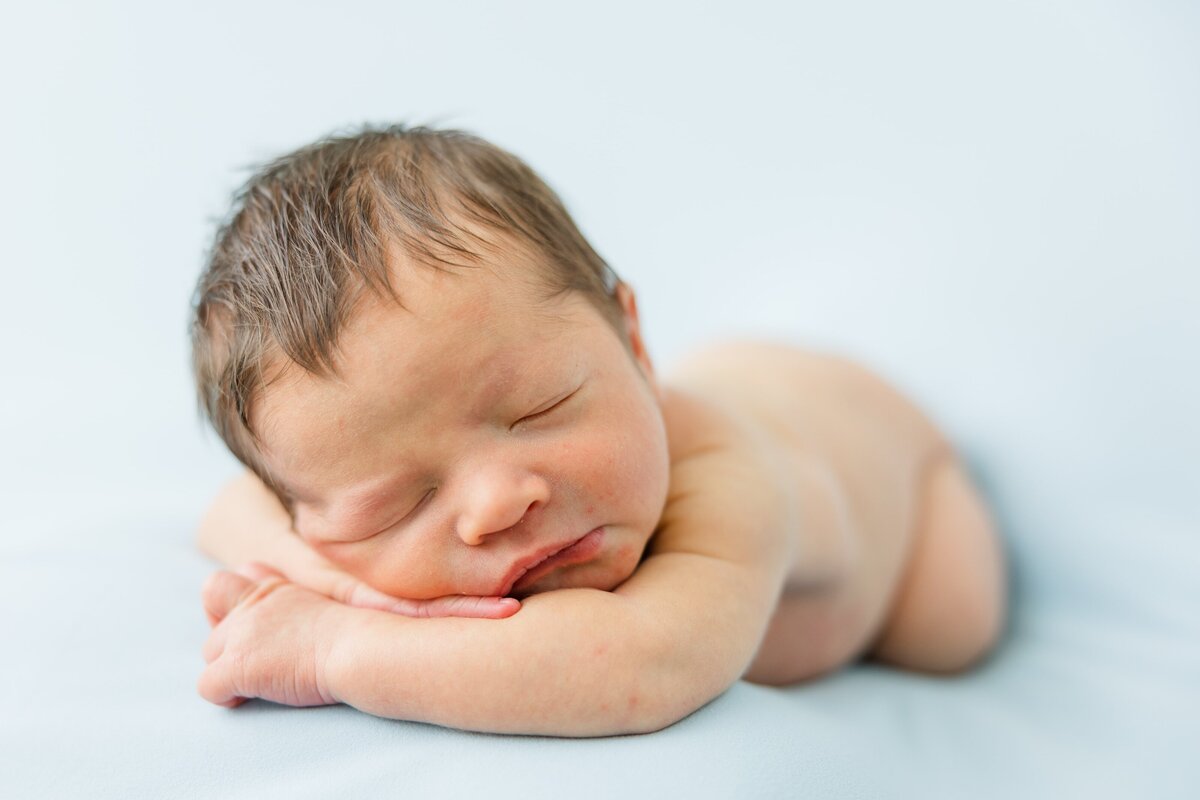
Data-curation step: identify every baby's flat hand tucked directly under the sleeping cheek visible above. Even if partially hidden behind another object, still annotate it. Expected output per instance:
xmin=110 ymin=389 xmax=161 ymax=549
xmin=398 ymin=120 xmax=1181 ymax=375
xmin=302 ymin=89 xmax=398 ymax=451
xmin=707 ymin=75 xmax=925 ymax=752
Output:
xmin=234 ymin=554 xmax=521 ymax=622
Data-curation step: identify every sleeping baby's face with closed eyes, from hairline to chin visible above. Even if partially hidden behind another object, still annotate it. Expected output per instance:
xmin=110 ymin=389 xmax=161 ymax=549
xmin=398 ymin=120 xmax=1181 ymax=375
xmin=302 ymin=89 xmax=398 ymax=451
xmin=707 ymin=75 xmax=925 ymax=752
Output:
xmin=252 ymin=256 xmax=668 ymax=599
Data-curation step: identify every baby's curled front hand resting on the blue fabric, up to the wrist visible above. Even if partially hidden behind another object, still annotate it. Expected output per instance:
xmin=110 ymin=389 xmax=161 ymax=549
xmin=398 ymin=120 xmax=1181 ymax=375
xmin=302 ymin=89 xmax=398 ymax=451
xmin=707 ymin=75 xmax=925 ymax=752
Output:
xmin=197 ymin=571 xmax=345 ymax=708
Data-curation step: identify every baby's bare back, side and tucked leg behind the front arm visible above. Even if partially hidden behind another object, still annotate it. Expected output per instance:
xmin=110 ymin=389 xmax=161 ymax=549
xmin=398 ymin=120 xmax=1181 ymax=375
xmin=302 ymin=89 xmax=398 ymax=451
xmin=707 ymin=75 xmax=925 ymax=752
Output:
xmin=668 ymin=342 xmax=1006 ymax=685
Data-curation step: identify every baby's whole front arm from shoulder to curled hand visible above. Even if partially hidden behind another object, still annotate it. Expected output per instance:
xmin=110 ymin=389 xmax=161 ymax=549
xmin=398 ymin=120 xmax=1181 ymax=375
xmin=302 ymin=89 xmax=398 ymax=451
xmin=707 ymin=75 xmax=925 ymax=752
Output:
xmin=200 ymin=438 xmax=791 ymax=736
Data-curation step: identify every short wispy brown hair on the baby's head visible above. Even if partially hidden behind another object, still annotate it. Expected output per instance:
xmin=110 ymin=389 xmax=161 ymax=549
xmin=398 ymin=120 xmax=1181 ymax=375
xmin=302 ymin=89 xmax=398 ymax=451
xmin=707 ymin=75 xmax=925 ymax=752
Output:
xmin=191 ymin=125 xmax=623 ymax=507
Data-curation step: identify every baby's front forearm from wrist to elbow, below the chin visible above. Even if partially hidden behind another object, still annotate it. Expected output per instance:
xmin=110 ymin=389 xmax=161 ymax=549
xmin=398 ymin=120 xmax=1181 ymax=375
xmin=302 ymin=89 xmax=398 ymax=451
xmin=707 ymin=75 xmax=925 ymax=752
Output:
xmin=328 ymin=589 xmax=737 ymax=736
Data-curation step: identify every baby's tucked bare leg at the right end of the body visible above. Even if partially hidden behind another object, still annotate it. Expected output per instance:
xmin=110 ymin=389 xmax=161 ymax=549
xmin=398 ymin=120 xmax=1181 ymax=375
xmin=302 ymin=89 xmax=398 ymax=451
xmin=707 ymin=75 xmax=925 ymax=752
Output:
xmin=869 ymin=449 xmax=1007 ymax=673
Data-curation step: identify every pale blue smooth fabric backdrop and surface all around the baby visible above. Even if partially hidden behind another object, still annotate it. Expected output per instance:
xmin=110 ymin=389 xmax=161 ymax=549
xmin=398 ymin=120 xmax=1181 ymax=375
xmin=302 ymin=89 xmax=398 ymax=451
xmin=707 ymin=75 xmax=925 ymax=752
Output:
xmin=0 ymin=0 xmax=1200 ymax=800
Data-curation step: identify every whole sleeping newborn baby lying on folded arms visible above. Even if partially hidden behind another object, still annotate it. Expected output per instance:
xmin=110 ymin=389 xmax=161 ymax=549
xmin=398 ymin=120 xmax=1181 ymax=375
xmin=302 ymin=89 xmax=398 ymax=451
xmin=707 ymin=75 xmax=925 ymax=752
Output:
xmin=192 ymin=126 xmax=1006 ymax=736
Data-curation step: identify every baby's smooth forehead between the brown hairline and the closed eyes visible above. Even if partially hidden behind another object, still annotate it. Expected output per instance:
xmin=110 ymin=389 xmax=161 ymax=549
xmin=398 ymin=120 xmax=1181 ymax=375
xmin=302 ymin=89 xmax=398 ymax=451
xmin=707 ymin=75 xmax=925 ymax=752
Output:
xmin=251 ymin=260 xmax=607 ymax=494
